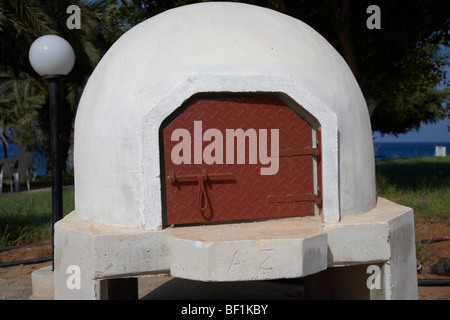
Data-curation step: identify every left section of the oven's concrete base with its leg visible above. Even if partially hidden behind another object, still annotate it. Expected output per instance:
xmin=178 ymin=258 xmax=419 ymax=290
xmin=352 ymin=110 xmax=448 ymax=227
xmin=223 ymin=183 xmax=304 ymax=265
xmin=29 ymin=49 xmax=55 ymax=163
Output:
xmin=54 ymin=212 xmax=169 ymax=300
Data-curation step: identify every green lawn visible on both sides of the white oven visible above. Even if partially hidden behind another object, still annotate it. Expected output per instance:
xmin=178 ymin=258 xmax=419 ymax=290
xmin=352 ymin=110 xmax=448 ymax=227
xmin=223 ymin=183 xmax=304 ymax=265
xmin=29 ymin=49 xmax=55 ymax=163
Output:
xmin=0 ymin=157 xmax=450 ymax=247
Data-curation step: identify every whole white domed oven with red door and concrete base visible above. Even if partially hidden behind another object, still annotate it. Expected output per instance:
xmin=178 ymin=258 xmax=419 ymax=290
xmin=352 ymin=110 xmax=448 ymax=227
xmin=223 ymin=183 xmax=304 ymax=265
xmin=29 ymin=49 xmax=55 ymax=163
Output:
xmin=55 ymin=3 xmax=417 ymax=299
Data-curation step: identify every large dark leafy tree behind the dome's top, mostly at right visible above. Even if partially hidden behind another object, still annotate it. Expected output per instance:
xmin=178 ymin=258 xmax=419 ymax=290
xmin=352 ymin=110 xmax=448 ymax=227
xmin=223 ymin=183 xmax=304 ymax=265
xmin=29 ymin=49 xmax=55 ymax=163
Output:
xmin=110 ymin=0 xmax=450 ymax=134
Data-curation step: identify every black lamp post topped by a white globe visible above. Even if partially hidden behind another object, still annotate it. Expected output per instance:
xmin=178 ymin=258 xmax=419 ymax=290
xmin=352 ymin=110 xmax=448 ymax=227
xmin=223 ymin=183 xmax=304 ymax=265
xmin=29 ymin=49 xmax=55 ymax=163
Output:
xmin=29 ymin=35 xmax=75 ymax=270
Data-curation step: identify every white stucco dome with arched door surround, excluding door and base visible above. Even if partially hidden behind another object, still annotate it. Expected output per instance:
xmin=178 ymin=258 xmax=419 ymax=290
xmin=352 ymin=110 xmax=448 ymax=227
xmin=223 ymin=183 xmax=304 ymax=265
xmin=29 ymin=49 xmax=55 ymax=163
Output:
xmin=74 ymin=3 xmax=376 ymax=229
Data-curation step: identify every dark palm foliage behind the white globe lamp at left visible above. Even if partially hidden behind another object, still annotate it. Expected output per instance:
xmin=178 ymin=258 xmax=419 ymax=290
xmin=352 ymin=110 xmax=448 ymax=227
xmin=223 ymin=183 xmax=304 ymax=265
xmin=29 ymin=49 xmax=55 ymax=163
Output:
xmin=0 ymin=0 xmax=122 ymax=171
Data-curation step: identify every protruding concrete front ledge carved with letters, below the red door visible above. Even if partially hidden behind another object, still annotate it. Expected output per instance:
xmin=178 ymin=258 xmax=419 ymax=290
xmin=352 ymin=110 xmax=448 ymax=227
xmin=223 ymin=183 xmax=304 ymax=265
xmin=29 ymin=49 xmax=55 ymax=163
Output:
xmin=170 ymin=219 xmax=327 ymax=281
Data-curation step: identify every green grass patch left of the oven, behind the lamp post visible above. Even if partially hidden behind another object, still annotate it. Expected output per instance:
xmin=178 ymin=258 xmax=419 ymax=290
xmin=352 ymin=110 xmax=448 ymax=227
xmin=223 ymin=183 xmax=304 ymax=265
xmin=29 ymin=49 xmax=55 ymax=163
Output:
xmin=0 ymin=187 xmax=74 ymax=247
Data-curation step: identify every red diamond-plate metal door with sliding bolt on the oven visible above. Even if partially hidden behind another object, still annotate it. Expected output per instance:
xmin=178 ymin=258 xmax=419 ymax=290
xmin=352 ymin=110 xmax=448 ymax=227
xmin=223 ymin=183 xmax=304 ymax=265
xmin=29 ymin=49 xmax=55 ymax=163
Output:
xmin=162 ymin=96 xmax=320 ymax=225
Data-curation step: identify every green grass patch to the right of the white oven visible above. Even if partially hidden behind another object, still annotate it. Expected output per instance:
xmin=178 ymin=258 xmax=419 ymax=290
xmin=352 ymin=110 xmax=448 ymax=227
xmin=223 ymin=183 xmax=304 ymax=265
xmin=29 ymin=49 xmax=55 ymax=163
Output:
xmin=376 ymin=156 xmax=450 ymax=220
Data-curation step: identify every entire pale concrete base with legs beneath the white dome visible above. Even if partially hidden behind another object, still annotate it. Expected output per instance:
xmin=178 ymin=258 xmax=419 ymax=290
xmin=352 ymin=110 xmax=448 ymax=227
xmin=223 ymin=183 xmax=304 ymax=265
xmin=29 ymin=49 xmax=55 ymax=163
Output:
xmin=51 ymin=198 xmax=418 ymax=299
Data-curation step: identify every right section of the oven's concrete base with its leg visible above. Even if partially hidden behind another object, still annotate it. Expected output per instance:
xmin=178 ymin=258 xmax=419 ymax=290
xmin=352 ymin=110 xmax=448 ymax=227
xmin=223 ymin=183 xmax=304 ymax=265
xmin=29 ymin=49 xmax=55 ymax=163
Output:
xmin=324 ymin=198 xmax=418 ymax=300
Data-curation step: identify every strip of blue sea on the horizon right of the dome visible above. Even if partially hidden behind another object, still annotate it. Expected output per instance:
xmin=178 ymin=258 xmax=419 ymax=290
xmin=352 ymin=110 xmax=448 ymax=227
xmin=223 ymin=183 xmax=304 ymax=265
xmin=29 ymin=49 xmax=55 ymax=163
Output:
xmin=373 ymin=141 xmax=450 ymax=160
